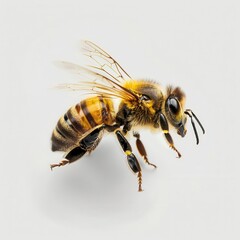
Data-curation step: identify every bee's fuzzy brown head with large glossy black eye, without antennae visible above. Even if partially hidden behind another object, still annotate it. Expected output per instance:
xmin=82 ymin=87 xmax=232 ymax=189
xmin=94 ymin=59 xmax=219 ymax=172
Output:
xmin=164 ymin=86 xmax=187 ymax=137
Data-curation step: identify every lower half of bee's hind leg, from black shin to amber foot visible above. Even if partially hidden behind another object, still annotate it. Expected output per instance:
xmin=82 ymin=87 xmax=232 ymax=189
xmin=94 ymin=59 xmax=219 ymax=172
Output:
xmin=50 ymin=147 xmax=87 ymax=170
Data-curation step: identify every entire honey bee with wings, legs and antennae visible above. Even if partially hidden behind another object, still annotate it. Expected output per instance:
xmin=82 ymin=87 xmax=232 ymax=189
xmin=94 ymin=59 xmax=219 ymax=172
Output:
xmin=51 ymin=41 xmax=205 ymax=191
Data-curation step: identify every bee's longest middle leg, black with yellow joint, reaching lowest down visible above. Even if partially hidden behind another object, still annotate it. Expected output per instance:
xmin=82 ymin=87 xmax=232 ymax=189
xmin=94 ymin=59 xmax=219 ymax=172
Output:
xmin=115 ymin=130 xmax=143 ymax=192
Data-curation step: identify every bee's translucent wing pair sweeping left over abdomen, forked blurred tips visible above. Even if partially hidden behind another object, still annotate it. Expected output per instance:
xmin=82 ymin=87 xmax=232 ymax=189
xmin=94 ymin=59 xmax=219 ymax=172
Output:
xmin=57 ymin=61 xmax=138 ymax=101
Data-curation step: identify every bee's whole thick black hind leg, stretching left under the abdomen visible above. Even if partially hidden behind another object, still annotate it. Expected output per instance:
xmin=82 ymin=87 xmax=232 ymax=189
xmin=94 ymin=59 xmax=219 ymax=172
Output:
xmin=50 ymin=128 xmax=102 ymax=169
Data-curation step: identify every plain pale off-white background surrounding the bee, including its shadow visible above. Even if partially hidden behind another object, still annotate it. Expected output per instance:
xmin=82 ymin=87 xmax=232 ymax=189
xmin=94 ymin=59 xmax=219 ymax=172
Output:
xmin=0 ymin=0 xmax=240 ymax=240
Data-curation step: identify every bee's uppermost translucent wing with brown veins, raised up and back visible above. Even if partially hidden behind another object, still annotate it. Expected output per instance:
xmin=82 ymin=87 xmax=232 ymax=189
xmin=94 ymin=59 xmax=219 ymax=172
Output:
xmin=82 ymin=41 xmax=131 ymax=83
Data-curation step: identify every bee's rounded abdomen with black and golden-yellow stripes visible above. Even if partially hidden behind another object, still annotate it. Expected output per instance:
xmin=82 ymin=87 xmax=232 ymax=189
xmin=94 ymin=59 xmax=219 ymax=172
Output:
xmin=51 ymin=97 xmax=115 ymax=151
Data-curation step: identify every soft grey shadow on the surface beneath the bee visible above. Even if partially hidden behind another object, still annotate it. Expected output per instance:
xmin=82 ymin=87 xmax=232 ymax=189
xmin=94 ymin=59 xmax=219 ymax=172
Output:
xmin=36 ymin=139 xmax=156 ymax=225
